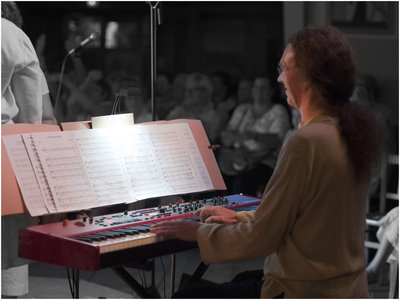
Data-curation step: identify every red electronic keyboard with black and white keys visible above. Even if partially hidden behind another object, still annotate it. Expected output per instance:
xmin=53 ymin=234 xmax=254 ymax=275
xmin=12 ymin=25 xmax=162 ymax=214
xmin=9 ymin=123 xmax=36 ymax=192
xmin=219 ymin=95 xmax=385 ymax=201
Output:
xmin=20 ymin=195 xmax=260 ymax=271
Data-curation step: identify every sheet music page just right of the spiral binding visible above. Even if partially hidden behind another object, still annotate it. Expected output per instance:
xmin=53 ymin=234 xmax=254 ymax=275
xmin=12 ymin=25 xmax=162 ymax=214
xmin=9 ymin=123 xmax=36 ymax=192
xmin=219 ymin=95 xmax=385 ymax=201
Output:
xmin=22 ymin=131 xmax=98 ymax=212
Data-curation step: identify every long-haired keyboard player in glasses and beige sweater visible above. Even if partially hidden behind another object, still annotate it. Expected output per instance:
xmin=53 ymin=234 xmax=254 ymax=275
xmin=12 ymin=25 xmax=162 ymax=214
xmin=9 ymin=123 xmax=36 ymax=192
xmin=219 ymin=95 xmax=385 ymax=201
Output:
xmin=151 ymin=27 xmax=381 ymax=298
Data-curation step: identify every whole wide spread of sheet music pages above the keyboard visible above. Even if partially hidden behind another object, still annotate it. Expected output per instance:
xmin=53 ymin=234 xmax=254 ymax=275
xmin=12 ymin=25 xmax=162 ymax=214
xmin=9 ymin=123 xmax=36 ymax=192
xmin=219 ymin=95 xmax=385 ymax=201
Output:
xmin=2 ymin=120 xmax=226 ymax=216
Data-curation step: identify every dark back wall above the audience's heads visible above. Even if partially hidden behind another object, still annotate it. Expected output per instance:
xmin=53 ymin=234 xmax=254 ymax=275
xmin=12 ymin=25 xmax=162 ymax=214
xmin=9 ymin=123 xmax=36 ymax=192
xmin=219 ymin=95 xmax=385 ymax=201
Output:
xmin=18 ymin=1 xmax=284 ymax=88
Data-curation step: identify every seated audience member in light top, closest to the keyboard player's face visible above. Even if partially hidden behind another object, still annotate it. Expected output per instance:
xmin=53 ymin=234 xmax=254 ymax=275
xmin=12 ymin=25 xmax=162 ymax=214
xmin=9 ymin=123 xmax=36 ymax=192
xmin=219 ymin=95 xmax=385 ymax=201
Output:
xmin=218 ymin=77 xmax=290 ymax=195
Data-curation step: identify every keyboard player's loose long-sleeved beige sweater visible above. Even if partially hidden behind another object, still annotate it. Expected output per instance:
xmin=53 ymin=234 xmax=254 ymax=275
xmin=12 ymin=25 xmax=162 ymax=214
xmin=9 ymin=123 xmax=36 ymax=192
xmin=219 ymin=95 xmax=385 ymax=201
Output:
xmin=197 ymin=116 xmax=369 ymax=298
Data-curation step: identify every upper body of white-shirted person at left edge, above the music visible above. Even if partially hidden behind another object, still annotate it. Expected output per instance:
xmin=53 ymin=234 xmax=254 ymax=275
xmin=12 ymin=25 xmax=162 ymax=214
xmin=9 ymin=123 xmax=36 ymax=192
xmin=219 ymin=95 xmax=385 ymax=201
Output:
xmin=1 ymin=1 xmax=57 ymax=124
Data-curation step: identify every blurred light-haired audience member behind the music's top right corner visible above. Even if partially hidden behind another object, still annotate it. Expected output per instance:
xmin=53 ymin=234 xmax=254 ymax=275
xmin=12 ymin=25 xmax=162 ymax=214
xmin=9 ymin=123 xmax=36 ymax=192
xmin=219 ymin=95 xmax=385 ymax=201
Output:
xmin=167 ymin=73 xmax=221 ymax=143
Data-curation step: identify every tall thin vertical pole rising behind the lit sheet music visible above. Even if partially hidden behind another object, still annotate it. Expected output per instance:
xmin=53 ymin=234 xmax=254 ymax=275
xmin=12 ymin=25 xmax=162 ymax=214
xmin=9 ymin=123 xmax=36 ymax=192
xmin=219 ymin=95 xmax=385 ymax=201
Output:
xmin=148 ymin=1 xmax=161 ymax=121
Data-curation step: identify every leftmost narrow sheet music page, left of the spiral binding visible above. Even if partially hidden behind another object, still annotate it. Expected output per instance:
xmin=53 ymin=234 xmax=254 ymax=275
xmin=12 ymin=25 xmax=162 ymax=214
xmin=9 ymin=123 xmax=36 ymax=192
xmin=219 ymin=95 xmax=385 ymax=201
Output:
xmin=3 ymin=135 xmax=49 ymax=217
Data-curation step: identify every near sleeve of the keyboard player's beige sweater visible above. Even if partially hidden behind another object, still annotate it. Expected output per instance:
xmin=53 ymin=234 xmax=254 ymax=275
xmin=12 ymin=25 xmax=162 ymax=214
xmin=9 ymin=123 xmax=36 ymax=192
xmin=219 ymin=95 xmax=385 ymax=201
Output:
xmin=197 ymin=136 xmax=309 ymax=263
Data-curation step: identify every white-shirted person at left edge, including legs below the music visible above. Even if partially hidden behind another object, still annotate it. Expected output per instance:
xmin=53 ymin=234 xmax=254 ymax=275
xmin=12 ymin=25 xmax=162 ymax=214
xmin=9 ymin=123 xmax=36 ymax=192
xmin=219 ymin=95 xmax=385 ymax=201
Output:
xmin=1 ymin=1 xmax=57 ymax=298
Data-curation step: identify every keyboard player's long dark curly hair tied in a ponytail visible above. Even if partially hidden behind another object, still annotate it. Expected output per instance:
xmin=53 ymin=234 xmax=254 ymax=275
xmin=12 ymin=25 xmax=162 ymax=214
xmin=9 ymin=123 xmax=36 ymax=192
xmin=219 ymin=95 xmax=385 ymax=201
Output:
xmin=289 ymin=26 xmax=384 ymax=181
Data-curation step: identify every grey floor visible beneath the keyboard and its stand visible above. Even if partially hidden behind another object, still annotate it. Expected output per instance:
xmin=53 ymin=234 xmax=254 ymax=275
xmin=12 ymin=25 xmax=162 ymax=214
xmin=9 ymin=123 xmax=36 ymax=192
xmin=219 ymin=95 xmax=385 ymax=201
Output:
xmin=17 ymin=250 xmax=389 ymax=299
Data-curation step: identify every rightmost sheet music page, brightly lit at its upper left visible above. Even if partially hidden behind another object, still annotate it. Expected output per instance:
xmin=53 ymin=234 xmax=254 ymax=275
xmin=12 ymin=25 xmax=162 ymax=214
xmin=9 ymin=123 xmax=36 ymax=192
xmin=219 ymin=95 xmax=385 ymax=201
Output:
xmin=118 ymin=124 xmax=213 ymax=199
